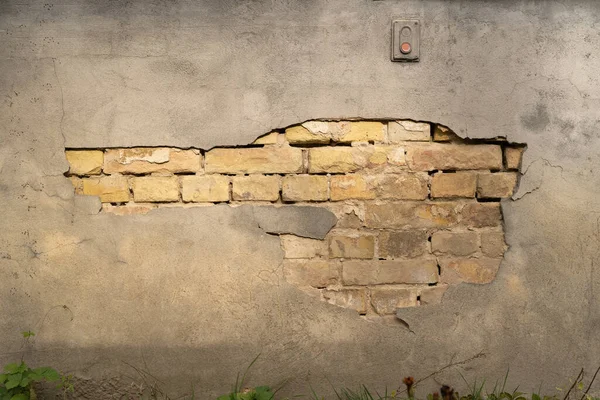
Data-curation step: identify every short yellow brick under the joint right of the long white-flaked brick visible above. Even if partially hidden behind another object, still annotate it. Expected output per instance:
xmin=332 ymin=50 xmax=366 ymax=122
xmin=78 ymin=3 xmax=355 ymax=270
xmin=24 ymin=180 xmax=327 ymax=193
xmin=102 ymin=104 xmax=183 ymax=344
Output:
xmin=181 ymin=175 xmax=229 ymax=203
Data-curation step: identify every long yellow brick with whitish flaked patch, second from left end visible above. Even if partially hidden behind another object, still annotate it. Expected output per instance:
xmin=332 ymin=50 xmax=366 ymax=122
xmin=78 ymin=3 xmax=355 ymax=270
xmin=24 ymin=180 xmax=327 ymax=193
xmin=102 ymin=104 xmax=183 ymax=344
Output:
xmin=104 ymin=147 xmax=202 ymax=174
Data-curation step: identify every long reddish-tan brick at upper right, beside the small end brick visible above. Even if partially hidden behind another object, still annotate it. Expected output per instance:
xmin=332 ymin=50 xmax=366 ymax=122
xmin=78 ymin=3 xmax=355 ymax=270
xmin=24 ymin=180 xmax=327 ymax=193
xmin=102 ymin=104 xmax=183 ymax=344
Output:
xmin=406 ymin=143 xmax=502 ymax=171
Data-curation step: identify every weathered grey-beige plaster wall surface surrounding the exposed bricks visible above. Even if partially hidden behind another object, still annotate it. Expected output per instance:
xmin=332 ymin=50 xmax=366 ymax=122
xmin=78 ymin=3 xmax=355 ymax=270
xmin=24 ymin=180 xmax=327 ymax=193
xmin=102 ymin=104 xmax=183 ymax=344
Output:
xmin=0 ymin=0 xmax=600 ymax=399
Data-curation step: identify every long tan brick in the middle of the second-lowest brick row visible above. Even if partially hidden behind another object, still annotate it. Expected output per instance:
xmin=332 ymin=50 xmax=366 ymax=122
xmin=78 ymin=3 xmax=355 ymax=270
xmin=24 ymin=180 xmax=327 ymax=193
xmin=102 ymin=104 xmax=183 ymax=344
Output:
xmin=342 ymin=259 xmax=438 ymax=285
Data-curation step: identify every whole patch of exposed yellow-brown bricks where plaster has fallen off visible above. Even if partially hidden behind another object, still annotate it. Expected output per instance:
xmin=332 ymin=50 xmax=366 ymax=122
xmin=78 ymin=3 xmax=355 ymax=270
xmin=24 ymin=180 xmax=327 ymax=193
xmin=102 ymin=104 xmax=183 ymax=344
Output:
xmin=65 ymin=120 xmax=525 ymax=319
